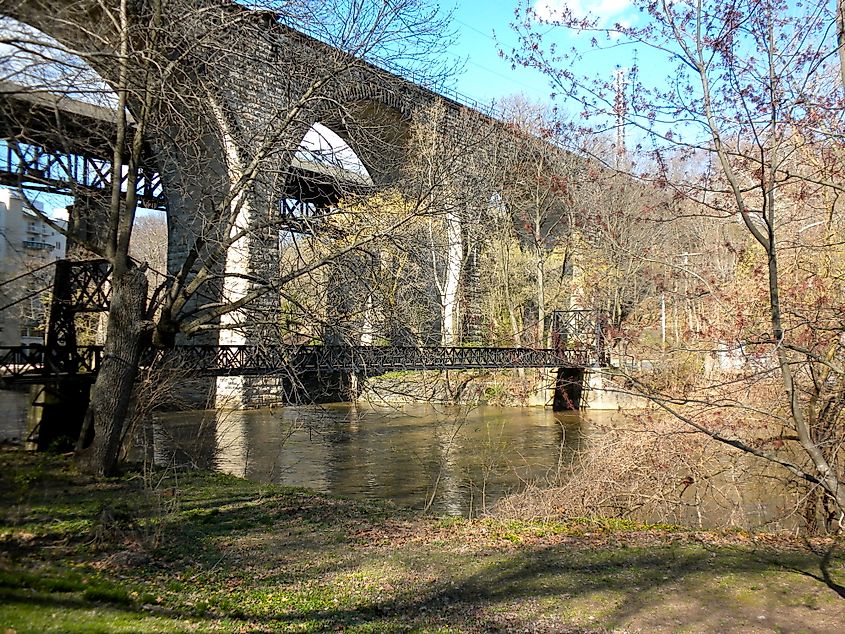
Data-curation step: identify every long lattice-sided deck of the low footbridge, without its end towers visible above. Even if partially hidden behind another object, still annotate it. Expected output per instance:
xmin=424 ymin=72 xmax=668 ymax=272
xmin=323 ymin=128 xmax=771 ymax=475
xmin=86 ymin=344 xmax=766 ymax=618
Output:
xmin=0 ymin=346 xmax=606 ymax=383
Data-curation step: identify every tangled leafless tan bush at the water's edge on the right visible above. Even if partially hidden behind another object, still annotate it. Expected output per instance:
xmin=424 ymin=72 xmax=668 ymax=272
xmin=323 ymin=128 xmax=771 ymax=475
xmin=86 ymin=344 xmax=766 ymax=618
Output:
xmin=493 ymin=414 xmax=801 ymax=528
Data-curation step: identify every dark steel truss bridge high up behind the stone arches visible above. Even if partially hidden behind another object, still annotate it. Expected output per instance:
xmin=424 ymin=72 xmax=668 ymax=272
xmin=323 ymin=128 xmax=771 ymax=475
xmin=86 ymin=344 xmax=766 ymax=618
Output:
xmin=0 ymin=80 xmax=372 ymax=212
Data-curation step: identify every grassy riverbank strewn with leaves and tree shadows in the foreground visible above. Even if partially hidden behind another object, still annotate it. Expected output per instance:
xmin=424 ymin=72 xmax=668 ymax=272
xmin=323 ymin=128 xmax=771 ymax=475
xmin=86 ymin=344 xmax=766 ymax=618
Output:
xmin=0 ymin=450 xmax=845 ymax=634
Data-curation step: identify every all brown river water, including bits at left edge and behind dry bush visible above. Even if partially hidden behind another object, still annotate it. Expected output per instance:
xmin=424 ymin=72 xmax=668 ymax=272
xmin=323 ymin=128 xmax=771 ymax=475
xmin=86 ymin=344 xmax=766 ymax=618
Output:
xmin=0 ymin=390 xmax=795 ymax=528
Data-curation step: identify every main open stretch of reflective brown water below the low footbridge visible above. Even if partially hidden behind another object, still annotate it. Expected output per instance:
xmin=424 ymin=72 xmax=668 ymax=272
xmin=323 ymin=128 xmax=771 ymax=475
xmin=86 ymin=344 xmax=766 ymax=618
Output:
xmin=153 ymin=403 xmax=586 ymax=515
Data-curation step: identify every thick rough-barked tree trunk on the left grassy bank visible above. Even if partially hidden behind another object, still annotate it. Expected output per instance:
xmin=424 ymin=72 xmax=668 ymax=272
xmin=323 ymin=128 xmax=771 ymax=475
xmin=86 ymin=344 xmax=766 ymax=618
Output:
xmin=81 ymin=268 xmax=149 ymax=476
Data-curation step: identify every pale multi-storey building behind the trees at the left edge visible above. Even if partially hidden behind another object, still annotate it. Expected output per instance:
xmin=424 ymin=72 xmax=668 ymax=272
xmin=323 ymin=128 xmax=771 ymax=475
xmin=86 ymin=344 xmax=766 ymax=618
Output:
xmin=0 ymin=189 xmax=66 ymax=346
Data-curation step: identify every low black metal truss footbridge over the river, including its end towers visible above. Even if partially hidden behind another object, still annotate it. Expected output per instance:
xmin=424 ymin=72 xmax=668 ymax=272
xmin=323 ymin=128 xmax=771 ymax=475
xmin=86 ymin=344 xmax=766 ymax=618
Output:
xmin=0 ymin=260 xmax=608 ymax=384
